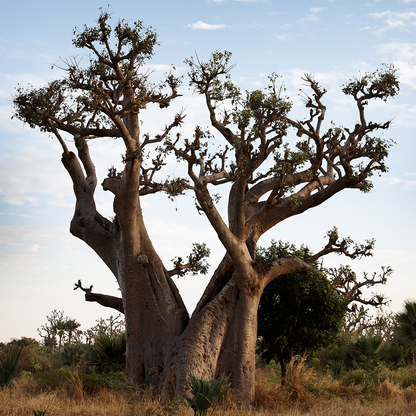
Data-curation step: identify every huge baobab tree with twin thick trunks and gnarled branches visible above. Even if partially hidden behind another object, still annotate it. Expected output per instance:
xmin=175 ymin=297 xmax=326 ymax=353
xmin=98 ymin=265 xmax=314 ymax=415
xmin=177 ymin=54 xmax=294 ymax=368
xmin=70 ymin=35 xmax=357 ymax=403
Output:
xmin=14 ymin=12 xmax=399 ymax=402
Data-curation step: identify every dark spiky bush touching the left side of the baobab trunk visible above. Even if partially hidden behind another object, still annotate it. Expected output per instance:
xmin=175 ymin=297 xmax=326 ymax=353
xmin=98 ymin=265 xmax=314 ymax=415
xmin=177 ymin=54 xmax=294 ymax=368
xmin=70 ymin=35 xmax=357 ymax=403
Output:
xmin=88 ymin=334 xmax=126 ymax=372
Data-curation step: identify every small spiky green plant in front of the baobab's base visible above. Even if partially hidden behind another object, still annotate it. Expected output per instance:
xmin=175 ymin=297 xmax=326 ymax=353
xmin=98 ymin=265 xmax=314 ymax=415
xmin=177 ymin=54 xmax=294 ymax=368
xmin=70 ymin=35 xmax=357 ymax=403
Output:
xmin=186 ymin=371 xmax=230 ymax=416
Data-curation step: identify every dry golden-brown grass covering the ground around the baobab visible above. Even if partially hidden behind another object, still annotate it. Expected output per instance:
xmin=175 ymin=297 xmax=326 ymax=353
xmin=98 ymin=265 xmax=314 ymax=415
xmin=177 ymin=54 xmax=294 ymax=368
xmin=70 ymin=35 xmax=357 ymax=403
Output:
xmin=0 ymin=358 xmax=416 ymax=416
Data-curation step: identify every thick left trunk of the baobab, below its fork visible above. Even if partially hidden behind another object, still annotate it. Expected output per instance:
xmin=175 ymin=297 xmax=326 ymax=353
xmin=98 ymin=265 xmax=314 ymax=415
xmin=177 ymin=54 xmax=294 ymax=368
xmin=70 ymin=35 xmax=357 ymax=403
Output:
xmin=118 ymin=219 xmax=189 ymax=387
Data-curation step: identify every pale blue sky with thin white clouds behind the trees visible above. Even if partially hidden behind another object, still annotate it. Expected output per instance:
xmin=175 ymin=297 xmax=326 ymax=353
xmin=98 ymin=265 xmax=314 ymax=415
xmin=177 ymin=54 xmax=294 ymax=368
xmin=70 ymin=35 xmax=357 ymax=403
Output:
xmin=0 ymin=0 xmax=416 ymax=342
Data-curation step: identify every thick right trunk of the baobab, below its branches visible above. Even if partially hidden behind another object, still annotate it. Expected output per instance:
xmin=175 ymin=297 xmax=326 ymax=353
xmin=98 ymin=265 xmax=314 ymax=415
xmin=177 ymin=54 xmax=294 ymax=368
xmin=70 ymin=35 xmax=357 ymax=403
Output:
xmin=174 ymin=264 xmax=262 ymax=405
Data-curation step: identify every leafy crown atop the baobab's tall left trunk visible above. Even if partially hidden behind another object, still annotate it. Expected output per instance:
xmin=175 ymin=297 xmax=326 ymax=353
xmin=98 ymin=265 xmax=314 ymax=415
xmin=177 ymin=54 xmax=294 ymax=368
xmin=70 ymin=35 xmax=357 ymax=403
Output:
xmin=13 ymin=12 xmax=174 ymax=136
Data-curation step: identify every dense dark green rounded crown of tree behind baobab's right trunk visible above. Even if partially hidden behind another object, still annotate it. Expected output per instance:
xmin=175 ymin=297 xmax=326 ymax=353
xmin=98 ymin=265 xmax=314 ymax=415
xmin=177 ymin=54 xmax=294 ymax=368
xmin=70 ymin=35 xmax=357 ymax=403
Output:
xmin=257 ymin=241 xmax=346 ymax=368
